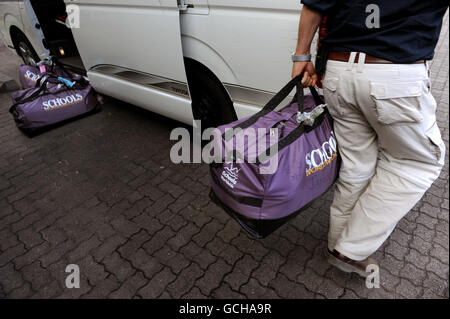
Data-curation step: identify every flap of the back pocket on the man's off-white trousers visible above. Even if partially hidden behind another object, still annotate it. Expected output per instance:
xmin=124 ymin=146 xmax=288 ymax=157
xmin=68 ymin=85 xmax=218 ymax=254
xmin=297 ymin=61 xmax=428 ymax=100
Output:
xmin=370 ymin=81 xmax=423 ymax=100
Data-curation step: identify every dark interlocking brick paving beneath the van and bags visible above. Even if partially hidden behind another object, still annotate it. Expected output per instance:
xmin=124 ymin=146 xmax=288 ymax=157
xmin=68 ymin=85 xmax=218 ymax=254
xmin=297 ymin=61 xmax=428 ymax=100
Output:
xmin=0 ymin=16 xmax=449 ymax=298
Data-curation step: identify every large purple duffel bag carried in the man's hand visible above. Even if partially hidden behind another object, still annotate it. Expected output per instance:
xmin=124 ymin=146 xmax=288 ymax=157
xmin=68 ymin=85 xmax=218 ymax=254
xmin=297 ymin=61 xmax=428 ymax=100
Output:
xmin=210 ymin=77 xmax=340 ymax=238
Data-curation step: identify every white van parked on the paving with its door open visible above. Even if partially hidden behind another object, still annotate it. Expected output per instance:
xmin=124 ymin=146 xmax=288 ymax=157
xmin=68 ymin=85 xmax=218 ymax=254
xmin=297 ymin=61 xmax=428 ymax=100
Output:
xmin=0 ymin=0 xmax=316 ymax=126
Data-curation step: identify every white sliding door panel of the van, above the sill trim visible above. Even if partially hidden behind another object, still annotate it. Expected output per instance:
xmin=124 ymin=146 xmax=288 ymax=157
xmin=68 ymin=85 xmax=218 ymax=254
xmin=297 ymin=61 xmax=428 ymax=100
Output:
xmin=65 ymin=0 xmax=187 ymax=83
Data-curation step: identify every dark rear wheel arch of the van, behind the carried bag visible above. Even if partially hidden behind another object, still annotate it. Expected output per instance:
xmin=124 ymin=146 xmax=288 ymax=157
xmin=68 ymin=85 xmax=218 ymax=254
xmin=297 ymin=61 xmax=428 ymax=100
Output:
xmin=184 ymin=57 xmax=237 ymax=129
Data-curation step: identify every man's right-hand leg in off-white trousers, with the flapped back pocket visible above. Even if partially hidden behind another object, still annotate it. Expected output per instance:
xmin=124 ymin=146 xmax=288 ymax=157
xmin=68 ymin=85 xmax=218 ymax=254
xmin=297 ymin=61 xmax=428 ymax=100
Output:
xmin=335 ymin=65 xmax=445 ymax=260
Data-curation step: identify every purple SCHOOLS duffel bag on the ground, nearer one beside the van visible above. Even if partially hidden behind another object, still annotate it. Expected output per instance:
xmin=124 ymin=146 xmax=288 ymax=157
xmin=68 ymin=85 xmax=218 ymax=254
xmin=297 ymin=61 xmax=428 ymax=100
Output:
xmin=9 ymin=74 xmax=100 ymax=135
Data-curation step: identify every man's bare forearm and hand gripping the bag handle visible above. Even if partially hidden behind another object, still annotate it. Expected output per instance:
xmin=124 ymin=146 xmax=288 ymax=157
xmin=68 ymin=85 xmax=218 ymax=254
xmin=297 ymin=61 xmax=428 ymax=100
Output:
xmin=292 ymin=5 xmax=322 ymax=87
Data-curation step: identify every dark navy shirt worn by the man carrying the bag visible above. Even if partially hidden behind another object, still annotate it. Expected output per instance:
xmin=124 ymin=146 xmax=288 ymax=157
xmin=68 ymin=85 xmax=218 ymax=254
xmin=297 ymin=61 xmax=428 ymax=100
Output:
xmin=302 ymin=0 xmax=449 ymax=63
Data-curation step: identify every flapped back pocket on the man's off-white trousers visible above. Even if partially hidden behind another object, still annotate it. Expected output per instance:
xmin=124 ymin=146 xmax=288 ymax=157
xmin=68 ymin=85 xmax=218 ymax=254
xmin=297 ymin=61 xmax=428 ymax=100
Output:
xmin=370 ymin=80 xmax=424 ymax=125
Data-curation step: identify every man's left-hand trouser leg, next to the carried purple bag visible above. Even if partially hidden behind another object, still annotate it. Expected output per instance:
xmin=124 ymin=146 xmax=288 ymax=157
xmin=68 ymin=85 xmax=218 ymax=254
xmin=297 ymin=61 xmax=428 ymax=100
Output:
xmin=324 ymin=62 xmax=378 ymax=251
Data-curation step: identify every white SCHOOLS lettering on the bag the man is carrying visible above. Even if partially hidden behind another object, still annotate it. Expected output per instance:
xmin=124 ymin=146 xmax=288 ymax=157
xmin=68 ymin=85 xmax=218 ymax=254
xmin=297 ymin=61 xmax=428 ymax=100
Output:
xmin=306 ymin=132 xmax=338 ymax=176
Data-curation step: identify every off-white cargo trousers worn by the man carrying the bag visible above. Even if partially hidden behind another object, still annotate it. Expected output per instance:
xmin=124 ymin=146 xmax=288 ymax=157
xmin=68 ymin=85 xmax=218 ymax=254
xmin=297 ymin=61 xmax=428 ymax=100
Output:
xmin=323 ymin=54 xmax=445 ymax=260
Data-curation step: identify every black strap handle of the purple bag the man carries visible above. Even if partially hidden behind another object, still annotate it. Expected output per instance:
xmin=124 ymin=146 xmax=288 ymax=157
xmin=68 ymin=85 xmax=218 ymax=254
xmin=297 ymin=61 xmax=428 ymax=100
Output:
xmin=222 ymin=73 xmax=323 ymax=141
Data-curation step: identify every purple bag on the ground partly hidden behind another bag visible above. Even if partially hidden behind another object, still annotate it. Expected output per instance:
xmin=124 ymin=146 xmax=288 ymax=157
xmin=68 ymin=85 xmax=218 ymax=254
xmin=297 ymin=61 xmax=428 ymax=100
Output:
xmin=19 ymin=64 xmax=82 ymax=89
